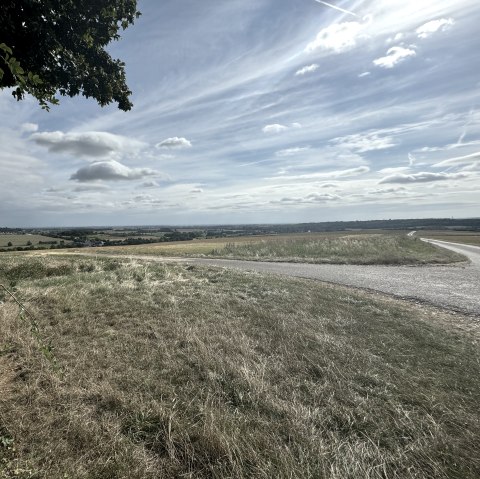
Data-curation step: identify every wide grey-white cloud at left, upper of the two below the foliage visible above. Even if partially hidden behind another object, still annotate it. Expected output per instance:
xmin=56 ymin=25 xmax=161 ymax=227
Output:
xmin=30 ymin=131 xmax=145 ymax=157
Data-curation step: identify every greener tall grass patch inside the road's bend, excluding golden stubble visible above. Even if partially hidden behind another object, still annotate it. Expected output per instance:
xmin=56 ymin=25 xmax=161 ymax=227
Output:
xmin=210 ymin=234 xmax=466 ymax=264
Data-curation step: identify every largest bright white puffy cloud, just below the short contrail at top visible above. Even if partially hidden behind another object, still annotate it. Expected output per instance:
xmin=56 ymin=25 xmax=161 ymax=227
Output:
xmin=305 ymin=21 xmax=369 ymax=53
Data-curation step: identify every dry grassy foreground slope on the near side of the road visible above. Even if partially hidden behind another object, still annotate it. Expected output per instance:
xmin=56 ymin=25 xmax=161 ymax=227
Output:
xmin=0 ymin=254 xmax=480 ymax=479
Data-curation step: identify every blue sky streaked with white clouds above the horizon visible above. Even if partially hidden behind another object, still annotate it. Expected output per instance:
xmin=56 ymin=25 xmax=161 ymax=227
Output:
xmin=0 ymin=0 xmax=480 ymax=227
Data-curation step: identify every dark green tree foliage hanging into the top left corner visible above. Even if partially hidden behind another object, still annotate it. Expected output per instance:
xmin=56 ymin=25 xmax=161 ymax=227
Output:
xmin=0 ymin=0 xmax=140 ymax=111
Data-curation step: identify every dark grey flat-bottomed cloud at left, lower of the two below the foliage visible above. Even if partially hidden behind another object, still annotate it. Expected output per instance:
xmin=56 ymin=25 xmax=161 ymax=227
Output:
xmin=70 ymin=160 xmax=158 ymax=183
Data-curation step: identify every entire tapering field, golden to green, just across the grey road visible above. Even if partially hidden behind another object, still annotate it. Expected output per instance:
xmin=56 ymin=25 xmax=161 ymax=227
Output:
xmin=78 ymin=233 xmax=465 ymax=264
